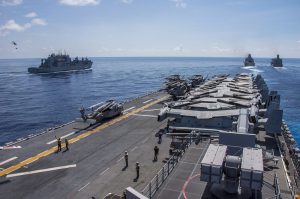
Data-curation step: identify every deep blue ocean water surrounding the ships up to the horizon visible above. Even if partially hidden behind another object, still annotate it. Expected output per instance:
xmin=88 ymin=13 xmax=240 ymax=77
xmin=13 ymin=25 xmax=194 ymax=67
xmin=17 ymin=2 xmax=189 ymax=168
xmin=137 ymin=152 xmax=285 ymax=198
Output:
xmin=0 ymin=57 xmax=300 ymax=145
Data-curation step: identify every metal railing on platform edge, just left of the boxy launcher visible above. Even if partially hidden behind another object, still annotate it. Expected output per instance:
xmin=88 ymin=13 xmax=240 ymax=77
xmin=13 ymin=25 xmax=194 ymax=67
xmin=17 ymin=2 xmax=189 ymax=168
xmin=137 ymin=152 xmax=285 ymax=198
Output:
xmin=142 ymin=140 xmax=191 ymax=199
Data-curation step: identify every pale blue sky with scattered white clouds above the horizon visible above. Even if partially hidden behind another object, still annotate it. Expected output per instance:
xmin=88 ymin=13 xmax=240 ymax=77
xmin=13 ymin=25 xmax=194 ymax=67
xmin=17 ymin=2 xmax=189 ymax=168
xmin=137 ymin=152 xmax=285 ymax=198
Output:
xmin=0 ymin=0 xmax=300 ymax=59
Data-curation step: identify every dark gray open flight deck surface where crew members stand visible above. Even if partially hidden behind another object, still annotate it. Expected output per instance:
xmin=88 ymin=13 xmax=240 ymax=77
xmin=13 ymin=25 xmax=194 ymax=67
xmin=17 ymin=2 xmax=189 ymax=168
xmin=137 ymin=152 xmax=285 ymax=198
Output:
xmin=0 ymin=92 xmax=170 ymax=199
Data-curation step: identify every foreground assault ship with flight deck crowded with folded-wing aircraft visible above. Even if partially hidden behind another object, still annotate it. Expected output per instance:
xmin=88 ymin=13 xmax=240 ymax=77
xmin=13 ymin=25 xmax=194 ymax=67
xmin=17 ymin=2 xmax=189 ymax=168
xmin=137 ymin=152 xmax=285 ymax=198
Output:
xmin=0 ymin=74 xmax=300 ymax=199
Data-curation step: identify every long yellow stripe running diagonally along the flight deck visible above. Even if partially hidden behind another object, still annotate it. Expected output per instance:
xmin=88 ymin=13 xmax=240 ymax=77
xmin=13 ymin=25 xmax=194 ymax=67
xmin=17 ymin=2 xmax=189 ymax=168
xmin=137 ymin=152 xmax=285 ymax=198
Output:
xmin=0 ymin=97 xmax=167 ymax=177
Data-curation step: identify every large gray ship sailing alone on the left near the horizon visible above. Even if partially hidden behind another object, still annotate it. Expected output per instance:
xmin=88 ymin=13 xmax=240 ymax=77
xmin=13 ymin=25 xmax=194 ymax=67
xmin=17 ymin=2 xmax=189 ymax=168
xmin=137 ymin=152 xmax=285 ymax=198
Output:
xmin=28 ymin=54 xmax=93 ymax=74
